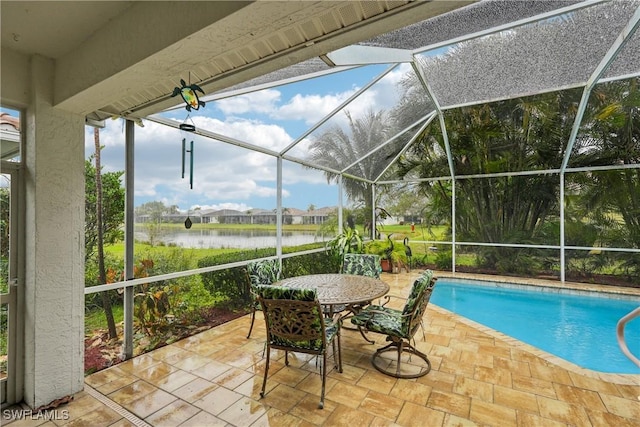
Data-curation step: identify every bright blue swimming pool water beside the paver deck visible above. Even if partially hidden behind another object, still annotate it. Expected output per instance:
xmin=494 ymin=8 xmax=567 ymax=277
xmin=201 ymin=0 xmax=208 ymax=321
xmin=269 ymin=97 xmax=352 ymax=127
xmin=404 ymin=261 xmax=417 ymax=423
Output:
xmin=431 ymin=278 xmax=640 ymax=374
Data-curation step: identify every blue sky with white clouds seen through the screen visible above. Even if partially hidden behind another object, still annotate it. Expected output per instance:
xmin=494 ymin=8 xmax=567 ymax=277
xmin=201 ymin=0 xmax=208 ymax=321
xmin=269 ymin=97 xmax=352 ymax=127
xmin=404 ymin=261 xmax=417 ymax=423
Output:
xmin=85 ymin=65 xmax=416 ymax=211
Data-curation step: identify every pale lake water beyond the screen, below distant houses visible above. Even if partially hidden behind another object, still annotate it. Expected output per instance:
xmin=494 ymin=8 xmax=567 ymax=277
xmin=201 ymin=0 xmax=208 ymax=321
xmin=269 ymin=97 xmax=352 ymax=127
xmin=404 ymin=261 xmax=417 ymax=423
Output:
xmin=136 ymin=227 xmax=329 ymax=249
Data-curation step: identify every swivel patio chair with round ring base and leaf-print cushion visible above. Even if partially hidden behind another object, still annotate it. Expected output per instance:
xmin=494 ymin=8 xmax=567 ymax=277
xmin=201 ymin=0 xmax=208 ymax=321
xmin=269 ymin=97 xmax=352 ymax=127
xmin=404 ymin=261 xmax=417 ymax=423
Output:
xmin=351 ymin=270 xmax=436 ymax=378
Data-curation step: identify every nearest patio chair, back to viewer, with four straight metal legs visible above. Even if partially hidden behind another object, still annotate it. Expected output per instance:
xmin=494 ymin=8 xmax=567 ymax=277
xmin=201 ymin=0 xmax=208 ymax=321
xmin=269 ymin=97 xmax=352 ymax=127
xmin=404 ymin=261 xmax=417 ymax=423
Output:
xmin=257 ymin=286 xmax=342 ymax=409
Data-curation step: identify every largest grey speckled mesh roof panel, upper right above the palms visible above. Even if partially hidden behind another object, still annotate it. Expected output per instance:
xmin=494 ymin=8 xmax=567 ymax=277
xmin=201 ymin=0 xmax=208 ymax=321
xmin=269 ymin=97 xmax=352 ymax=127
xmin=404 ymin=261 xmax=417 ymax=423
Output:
xmin=412 ymin=2 xmax=637 ymax=108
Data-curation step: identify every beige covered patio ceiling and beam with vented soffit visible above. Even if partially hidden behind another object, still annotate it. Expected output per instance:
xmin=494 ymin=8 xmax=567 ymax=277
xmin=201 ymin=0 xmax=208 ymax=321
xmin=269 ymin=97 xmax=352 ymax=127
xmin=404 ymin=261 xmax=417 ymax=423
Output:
xmin=1 ymin=0 xmax=474 ymax=119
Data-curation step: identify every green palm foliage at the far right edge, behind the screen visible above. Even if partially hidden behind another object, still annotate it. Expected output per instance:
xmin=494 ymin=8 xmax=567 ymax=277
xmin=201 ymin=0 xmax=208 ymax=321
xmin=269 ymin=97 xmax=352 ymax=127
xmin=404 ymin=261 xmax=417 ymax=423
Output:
xmin=570 ymin=77 xmax=640 ymax=275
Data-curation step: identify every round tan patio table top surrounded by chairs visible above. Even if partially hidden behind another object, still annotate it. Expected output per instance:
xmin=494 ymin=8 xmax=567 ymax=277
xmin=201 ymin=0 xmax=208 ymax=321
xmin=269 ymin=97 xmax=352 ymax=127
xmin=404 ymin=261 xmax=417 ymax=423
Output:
xmin=274 ymin=274 xmax=389 ymax=343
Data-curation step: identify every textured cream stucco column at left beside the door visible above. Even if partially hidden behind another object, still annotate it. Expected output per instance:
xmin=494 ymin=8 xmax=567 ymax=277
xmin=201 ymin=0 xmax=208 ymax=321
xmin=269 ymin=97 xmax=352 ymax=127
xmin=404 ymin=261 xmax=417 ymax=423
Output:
xmin=24 ymin=57 xmax=84 ymax=408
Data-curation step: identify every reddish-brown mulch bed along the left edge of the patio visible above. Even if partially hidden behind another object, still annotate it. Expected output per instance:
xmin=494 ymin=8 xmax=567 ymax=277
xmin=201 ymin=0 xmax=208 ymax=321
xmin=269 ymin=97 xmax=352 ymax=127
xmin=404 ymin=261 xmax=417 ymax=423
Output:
xmin=84 ymin=307 xmax=246 ymax=375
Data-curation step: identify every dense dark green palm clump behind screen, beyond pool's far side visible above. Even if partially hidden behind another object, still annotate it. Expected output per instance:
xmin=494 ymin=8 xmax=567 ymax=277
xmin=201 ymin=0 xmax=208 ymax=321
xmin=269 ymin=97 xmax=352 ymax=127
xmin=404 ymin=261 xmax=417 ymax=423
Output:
xmin=395 ymin=83 xmax=580 ymax=267
